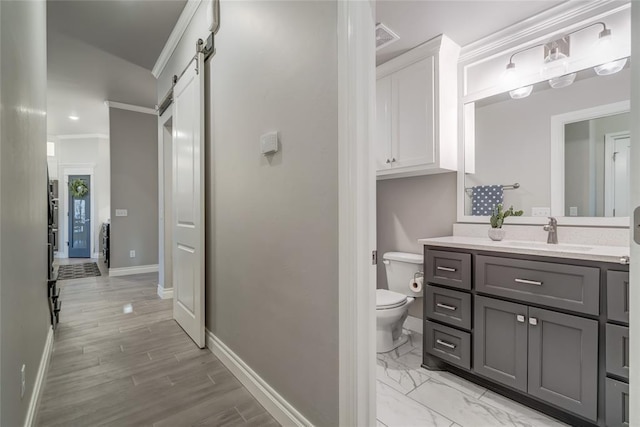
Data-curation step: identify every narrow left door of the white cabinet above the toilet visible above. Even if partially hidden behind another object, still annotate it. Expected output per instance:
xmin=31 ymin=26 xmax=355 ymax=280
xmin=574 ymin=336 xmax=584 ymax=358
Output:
xmin=375 ymin=76 xmax=391 ymax=170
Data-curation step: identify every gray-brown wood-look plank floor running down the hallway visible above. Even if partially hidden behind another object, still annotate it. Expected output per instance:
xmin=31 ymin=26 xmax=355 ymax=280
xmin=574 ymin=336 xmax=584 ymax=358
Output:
xmin=36 ymin=274 xmax=278 ymax=427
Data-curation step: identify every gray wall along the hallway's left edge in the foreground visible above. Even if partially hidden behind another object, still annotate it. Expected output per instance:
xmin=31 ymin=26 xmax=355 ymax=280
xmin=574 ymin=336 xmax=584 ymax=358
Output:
xmin=0 ymin=1 xmax=50 ymax=426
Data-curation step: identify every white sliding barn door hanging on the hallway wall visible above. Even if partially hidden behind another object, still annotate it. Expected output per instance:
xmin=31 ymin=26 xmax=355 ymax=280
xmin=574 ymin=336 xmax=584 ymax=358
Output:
xmin=171 ymin=54 xmax=205 ymax=348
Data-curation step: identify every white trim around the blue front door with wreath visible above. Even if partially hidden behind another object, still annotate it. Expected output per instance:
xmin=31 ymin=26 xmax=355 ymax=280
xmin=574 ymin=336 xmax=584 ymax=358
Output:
xmin=58 ymin=163 xmax=97 ymax=258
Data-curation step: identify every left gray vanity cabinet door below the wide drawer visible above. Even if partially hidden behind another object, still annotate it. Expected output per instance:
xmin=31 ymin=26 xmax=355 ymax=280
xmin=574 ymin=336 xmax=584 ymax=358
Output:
xmin=473 ymin=297 xmax=527 ymax=392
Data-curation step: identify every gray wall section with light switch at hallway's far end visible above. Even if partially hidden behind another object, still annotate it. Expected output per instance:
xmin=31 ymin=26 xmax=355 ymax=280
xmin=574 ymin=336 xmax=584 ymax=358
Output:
xmin=109 ymin=108 xmax=158 ymax=268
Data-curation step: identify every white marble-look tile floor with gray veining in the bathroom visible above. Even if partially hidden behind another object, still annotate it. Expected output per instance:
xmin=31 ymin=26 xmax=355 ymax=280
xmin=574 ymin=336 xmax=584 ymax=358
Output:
xmin=376 ymin=331 xmax=566 ymax=427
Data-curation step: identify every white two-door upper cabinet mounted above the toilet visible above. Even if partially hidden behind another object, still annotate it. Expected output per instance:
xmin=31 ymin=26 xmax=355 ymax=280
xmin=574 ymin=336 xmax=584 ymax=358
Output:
xmin=376 ymin=36 xmax=460 ymax=179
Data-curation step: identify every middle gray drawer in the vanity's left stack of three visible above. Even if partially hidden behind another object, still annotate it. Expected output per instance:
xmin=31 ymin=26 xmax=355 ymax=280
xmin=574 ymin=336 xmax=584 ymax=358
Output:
xmin=425 ymin=285 xmax=471 ymax=329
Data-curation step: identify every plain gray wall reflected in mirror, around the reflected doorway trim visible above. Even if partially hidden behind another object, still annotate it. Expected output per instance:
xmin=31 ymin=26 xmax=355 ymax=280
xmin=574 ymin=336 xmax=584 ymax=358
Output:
xmin=465 ymin=68 xmax=631 ymax=216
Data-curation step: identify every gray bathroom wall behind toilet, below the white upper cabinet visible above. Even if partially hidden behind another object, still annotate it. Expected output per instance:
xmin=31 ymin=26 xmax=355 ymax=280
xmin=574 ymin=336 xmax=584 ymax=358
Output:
xmin=377 ymin=172 xmax=456 ymax=318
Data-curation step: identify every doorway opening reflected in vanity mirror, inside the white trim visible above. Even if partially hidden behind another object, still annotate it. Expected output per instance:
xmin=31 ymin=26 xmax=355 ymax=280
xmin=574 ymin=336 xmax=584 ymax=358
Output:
xmin=564 ymin=112 xmax=631 ymax=217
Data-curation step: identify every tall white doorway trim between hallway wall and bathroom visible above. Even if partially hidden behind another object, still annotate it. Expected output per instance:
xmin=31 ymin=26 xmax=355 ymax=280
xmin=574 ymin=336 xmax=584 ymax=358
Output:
xmin=337 ymin=0 xmax=376 ymax=426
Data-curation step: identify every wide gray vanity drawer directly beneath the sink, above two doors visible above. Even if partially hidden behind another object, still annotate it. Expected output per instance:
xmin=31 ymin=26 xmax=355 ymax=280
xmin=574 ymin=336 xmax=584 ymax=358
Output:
xmin=475 ymin=255 xmax=600 ymax=315
